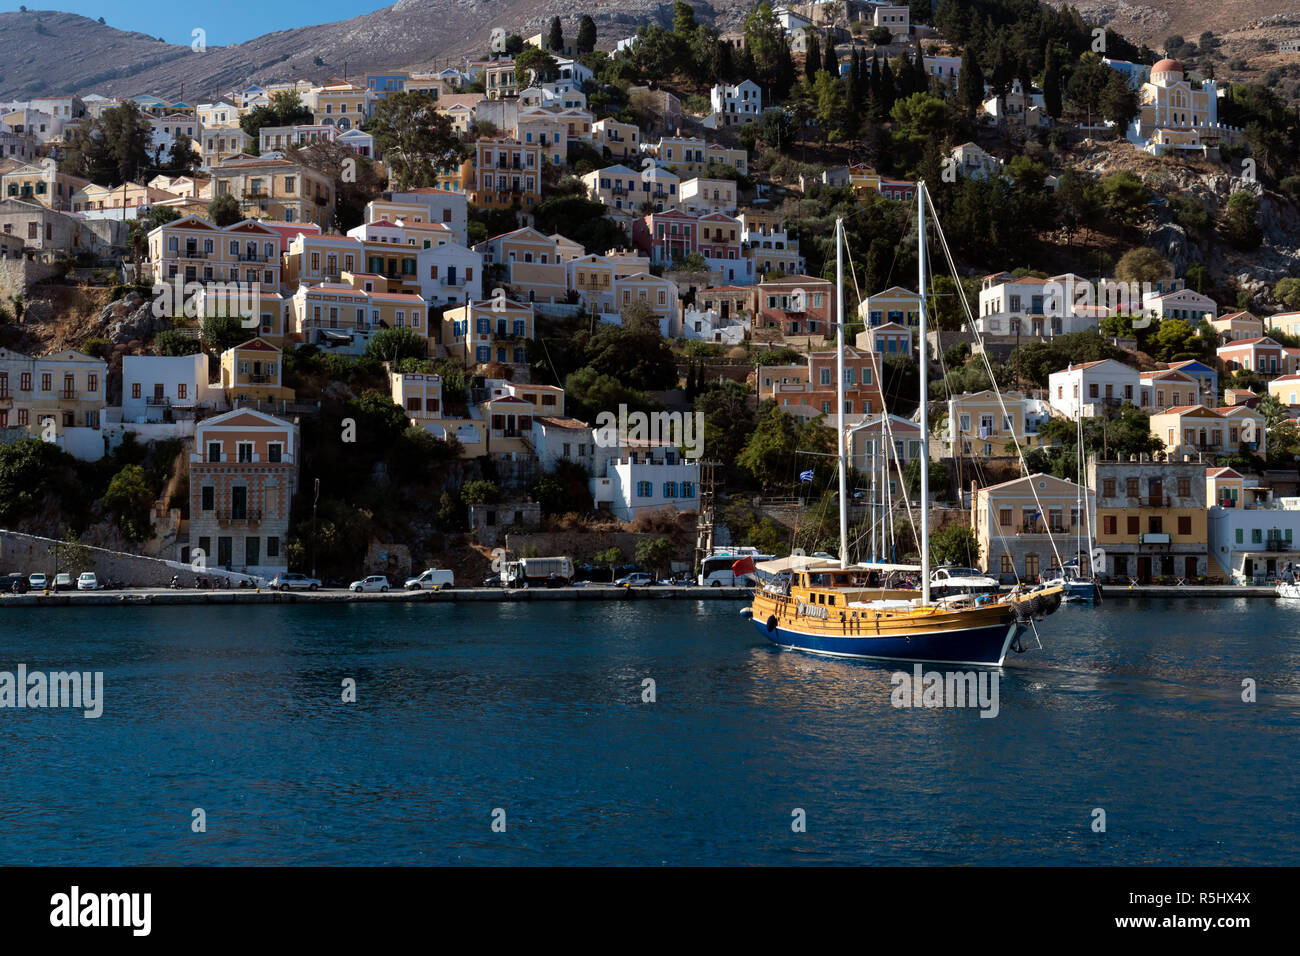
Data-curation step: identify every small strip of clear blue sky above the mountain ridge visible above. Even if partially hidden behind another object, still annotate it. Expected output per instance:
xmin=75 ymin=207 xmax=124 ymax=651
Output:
xmin=0 ymin=0 xmax=394 ymax=46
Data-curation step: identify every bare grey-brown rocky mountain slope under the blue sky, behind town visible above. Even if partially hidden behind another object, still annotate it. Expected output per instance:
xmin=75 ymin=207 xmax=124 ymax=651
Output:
xmin=0 ymin=0 xmax=750 ymax=103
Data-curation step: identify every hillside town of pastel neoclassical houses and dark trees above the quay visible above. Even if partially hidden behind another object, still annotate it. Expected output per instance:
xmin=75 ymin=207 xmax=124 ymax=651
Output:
xmin=0 ymin=0 xmax=1300 ymax=587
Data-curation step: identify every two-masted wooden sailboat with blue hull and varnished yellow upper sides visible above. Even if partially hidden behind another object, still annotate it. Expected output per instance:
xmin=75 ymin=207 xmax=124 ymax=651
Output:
xmin=744 ymin=182 xmax=1065 ymax=666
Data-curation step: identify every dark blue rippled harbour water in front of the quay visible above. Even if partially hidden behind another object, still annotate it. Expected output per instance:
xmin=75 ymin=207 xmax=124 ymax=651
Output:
xmin=0 ymin=600 xmax=1300 ymax=865
